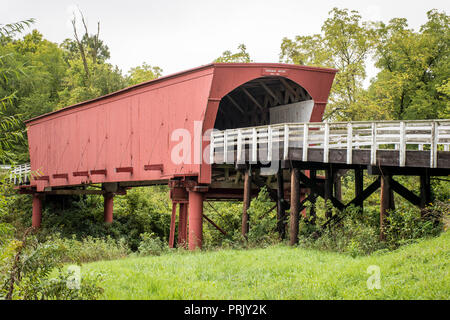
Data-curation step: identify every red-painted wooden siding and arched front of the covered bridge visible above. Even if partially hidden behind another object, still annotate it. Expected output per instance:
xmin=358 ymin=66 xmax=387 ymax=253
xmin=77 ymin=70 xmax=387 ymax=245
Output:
xmin=26 ymin=63 xmax=336 ymax=191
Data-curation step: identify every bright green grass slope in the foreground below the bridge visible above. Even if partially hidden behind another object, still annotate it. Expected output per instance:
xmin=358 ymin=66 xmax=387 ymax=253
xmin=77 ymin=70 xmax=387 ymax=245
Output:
xmin=82 ymin=232 xmax=450 ymax=299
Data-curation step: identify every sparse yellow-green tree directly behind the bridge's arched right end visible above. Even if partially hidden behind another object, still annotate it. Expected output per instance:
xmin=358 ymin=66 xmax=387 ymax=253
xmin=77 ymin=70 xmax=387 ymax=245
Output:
xmin=280 ymin=8 xmax=377 ymax=120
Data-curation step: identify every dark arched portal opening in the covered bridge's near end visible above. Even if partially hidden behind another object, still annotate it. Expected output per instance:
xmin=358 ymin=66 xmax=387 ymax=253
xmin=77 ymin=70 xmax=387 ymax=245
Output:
xmin=214 ymin=76 xmax=314 ymax=130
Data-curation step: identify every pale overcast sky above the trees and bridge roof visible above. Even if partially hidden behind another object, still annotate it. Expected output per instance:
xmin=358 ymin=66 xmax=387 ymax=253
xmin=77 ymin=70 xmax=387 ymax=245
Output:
xmin=0 ymin=0 xmax=450 ymax=82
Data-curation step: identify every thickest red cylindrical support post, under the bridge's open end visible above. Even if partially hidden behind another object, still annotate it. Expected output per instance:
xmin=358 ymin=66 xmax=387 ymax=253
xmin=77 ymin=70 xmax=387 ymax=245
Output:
xmin=189 ymin=190 xmax=203 ymax=250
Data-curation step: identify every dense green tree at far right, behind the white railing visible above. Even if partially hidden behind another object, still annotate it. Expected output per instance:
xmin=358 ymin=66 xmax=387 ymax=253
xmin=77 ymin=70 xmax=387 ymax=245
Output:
xmin=368 ymin=10 xmax=450 ymax=119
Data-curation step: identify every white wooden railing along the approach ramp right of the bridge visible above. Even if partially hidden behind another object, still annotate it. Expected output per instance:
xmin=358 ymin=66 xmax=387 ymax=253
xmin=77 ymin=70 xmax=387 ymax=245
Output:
xmin=210 ymin=119 xmax=450 ymax=168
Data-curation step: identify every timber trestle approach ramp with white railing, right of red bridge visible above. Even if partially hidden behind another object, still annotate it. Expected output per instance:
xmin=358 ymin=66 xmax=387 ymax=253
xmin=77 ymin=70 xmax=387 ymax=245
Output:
xmin=210 ymin=120 xmax=450 ymax=244
